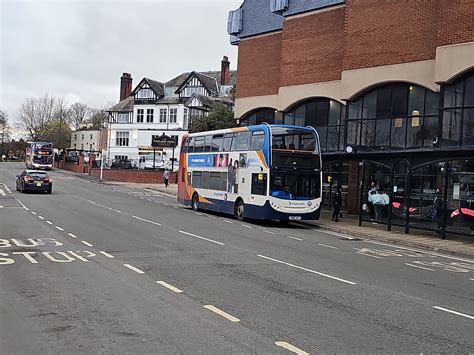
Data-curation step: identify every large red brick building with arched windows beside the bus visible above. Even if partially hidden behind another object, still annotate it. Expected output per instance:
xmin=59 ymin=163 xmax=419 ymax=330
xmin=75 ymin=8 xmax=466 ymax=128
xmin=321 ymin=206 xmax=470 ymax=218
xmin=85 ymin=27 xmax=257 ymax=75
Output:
xmin=228 ymin=0 xmax=474 ymax=235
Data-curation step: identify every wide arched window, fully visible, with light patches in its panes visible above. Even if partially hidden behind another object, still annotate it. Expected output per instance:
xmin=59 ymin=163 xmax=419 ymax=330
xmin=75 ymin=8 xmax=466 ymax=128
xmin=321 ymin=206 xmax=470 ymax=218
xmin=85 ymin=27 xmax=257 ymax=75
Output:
xmin=347 ymin=83 xmax=439 ymax=150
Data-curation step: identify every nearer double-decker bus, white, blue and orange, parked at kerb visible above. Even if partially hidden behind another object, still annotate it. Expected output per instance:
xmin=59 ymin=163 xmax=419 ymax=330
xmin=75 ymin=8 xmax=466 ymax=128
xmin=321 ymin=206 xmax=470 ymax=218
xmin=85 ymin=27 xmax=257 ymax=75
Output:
xmin=178 ymin=124 xmax=322 ymax=223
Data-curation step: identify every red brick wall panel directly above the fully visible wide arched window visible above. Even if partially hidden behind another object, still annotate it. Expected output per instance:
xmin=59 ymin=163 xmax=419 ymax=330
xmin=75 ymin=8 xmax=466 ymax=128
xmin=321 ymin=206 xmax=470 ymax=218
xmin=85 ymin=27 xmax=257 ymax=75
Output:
xmin=344 ymin=0 xmax=438 ymax=70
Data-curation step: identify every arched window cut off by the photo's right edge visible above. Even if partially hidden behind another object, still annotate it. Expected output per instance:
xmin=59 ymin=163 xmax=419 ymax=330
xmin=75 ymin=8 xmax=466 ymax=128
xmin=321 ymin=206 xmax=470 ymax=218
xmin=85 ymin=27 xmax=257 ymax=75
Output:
xmin=441 ymin=71 xmax=474 ymax=147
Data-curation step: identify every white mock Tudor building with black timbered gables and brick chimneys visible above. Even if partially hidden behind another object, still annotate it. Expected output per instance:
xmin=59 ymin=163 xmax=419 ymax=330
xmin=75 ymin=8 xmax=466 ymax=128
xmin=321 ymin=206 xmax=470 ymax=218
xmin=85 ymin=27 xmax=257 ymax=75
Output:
xmin=107 ymin=57 xmax=237 ymax=161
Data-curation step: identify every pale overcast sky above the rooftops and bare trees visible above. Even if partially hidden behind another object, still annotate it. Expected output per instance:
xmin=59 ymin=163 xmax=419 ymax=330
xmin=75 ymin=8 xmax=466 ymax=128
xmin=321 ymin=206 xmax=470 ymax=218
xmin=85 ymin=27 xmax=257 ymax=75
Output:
xmin=0 ymin=0 xmax=242 ymax=131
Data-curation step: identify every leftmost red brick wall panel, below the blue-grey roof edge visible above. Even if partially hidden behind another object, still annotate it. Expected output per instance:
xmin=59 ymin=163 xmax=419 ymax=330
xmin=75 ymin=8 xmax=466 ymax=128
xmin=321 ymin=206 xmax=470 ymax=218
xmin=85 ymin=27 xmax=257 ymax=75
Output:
xmin=237 ymin=33 xmax=281 ymax=97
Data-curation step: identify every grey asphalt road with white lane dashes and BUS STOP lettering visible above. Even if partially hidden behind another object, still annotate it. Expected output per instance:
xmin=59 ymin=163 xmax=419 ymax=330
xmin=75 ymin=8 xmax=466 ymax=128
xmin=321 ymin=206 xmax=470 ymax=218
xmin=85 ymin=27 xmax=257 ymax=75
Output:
xmin=0 ymin=163 xmax=474 ymax=354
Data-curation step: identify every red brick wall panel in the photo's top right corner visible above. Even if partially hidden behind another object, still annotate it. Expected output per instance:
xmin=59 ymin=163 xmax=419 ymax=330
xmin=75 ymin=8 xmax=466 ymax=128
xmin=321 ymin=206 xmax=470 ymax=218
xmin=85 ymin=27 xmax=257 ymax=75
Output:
xmin=436 ymin=0 xmax=474 ymax=46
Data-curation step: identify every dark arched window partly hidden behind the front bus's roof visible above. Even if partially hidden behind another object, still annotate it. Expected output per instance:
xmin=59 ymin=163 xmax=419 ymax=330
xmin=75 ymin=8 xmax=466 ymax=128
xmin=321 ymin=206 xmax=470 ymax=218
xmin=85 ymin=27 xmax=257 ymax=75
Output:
xmin=283 ymin=98 xmax=345 ymax=152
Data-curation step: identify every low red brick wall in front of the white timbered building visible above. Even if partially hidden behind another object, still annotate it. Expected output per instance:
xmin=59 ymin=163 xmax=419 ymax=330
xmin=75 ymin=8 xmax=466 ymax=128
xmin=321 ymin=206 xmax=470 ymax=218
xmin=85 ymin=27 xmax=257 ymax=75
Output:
xmin=91 ymin=168 xmax=177 ymax=184
